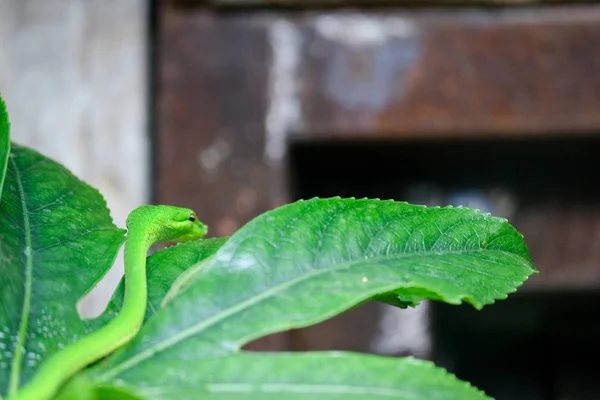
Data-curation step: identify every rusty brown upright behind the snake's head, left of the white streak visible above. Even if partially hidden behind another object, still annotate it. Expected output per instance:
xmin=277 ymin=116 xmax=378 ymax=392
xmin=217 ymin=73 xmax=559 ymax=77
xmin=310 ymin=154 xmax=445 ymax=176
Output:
xmin=155 ymin=7 xmax=287 ymax=350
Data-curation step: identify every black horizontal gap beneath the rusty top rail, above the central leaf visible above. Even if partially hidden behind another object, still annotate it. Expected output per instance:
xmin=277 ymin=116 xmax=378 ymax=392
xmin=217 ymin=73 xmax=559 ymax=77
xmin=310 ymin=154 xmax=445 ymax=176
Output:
xmin=290 ymin=135 xmax=600 ymax=207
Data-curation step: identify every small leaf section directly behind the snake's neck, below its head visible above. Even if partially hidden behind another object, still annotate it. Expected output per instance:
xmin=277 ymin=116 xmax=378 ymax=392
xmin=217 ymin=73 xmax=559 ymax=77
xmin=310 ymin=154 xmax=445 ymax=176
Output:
xmin=105 ymin=238 xmax=227 ymax=319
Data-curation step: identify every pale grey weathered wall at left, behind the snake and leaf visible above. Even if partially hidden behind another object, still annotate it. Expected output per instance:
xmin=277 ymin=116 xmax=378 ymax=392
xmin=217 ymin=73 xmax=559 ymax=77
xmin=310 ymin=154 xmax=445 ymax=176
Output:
xmin=0 ymin=0 xmax=149 ymax=313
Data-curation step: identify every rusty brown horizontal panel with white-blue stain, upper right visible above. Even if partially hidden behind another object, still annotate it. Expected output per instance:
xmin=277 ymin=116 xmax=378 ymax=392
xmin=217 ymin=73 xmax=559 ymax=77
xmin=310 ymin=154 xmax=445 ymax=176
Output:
xmin=299 ymin=7 xmax=600 ymax=139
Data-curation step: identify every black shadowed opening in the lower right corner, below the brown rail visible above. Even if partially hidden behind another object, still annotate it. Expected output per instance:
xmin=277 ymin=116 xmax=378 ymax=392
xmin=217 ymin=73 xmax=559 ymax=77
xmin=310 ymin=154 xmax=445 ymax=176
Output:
xmin=431 ymin=291 xmax=600 ymax=400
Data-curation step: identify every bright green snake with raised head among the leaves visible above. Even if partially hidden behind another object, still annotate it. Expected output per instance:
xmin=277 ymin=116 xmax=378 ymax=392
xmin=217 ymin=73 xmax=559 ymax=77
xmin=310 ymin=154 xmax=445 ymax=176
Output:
xmin=9 ymin=206 xmax=208 ymax=400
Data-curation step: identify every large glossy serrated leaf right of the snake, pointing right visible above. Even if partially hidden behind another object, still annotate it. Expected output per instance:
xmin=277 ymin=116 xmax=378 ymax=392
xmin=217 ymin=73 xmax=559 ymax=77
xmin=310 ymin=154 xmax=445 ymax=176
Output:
xmin=90 ymin=198 xmax=535 ymax=398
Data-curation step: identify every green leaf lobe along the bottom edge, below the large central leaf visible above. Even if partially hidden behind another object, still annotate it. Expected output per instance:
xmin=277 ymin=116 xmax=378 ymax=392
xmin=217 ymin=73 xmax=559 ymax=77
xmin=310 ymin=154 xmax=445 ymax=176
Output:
xmin=88 ymin=352 xmax=490 ymax=400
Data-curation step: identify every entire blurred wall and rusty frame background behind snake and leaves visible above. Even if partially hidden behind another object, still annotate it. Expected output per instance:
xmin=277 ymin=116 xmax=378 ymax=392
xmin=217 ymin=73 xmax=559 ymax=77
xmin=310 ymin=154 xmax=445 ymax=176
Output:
xmin=0 ymin=0 xmax=600 ymax=400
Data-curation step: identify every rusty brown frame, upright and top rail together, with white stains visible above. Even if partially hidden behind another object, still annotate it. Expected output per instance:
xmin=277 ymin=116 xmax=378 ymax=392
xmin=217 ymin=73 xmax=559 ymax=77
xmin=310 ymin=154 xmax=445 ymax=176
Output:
xmin=155 ymin=3 xmax=600 ymax=349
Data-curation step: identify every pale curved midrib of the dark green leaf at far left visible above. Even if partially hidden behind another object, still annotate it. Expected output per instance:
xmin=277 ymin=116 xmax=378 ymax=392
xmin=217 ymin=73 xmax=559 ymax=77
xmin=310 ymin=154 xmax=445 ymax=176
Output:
xmin=8 ymin=157 xmax=33 ymax=397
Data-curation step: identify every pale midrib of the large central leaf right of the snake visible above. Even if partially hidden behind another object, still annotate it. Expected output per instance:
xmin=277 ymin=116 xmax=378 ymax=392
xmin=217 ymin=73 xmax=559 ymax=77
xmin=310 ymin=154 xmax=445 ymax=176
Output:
xmin=98 ymin=249 xmax=522 ymax=381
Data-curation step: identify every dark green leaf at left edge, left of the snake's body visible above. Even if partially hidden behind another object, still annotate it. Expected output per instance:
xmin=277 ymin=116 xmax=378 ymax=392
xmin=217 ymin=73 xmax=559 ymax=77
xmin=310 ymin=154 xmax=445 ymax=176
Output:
xmin=0 ymin=145 xmax=124 ymax=394
